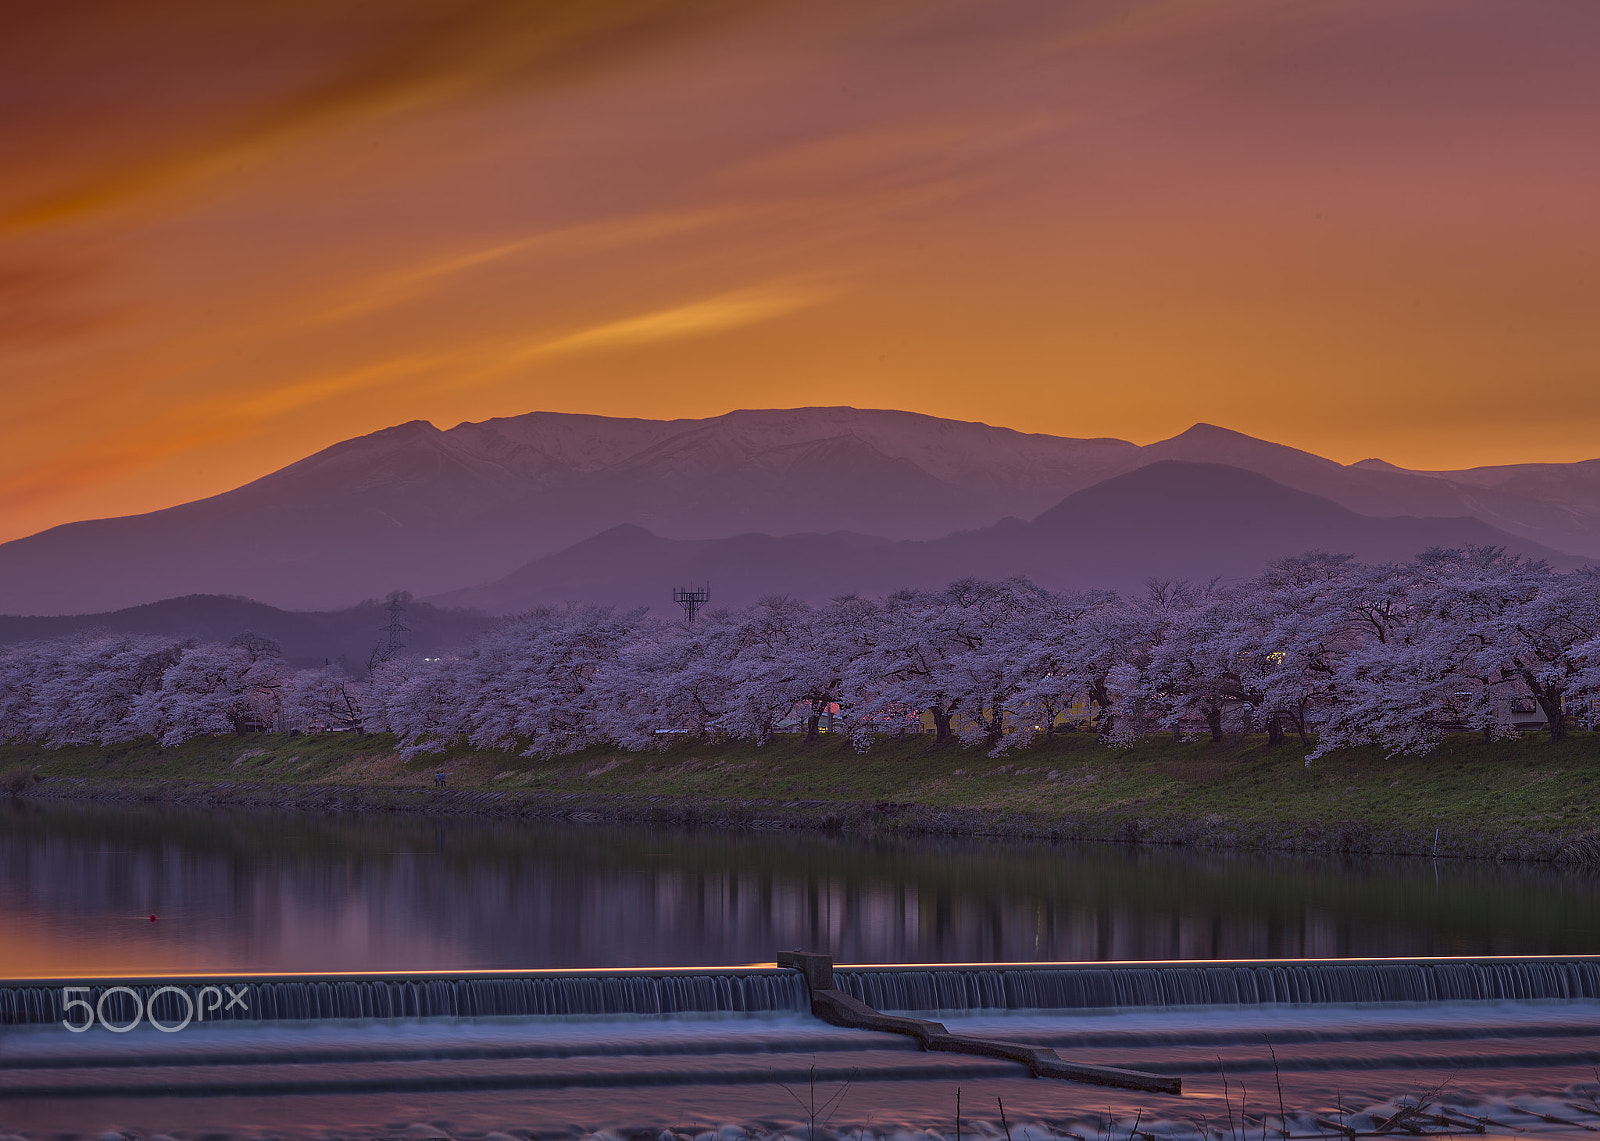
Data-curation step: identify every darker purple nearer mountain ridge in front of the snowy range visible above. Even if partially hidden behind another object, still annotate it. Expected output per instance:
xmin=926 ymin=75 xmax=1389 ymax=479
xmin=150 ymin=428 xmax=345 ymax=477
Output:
xmin=435 ymin=461 xmax=1574 ymax=613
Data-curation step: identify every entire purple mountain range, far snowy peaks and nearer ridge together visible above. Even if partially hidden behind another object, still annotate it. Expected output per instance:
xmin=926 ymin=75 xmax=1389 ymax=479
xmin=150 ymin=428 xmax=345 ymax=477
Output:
xmin=0 ymin=408 xmax=1600 ymax=615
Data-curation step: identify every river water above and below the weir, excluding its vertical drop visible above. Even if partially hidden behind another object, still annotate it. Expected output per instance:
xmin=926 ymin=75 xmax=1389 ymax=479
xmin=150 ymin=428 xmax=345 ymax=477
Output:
xmin=0 ymin=800 xmax=1600 ymax=1141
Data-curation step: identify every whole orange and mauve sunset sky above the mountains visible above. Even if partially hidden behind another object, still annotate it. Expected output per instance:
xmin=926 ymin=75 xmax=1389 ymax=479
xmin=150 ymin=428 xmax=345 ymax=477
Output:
xmin=0 ymin=0 xmax=1600 ymax=539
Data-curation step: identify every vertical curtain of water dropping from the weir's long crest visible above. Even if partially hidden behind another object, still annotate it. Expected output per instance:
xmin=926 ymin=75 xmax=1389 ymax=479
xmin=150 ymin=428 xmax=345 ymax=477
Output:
xmin=0 ymin=955 xmax=1600 ymax=1026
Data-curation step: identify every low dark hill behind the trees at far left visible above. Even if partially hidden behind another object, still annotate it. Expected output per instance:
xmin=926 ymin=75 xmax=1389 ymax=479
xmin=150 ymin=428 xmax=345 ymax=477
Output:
xmin=0 ymin=594 xmax=488 ymax=672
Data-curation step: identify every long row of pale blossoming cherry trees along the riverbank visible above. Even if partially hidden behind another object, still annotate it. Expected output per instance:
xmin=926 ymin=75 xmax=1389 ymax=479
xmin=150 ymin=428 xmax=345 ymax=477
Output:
xmin=0 ymin=547 xmax=1600 ymax=757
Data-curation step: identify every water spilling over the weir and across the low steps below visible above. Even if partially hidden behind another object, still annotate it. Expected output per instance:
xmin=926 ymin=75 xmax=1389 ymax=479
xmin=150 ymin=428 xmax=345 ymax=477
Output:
xmin=9 ymin=952 xmax=1600 ymax=1141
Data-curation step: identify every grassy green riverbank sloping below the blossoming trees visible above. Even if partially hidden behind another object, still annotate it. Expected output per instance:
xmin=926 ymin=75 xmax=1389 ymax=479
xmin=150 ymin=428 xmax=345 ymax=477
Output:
xmin=0 ymin=733 xmax=1600 ymax=859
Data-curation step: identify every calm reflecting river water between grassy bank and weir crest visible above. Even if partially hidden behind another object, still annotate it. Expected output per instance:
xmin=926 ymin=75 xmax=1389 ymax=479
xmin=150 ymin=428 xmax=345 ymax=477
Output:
xmin=0 ymin=800 xmax=1600 ymax=976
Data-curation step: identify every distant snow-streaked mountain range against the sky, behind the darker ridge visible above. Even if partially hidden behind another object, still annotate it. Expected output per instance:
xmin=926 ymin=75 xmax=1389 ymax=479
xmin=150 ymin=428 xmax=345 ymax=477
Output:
xmin=0 ymin=408 xmax=1600 ymax=615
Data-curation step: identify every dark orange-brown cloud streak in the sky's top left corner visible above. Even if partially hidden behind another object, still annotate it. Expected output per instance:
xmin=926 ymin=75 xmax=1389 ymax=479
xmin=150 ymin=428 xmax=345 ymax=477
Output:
xmin=0 ymin=0 xmax=764 ymax=235
